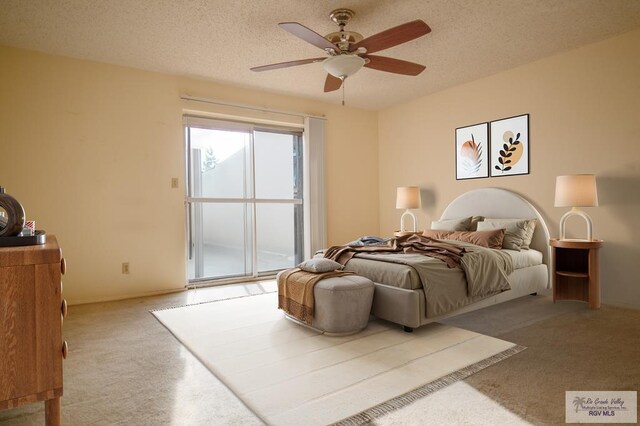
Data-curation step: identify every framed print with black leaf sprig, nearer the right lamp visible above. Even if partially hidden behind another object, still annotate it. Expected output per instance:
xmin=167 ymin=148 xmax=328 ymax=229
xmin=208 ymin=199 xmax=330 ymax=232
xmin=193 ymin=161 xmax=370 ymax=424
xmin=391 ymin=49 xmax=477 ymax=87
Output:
xmin=490 ymin=114 xmax=529 ymax=177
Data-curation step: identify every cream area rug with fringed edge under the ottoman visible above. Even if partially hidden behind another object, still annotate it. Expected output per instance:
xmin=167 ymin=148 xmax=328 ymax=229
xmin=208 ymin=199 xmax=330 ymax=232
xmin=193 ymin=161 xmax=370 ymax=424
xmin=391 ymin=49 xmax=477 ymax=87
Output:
xmin=153 ymin=293 xmax=524 ymax=425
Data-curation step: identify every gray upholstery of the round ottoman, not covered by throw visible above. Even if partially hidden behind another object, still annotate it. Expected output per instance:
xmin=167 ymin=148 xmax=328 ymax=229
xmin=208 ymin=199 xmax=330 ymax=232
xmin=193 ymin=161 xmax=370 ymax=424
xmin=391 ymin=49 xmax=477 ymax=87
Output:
xmin=278 ymin=275 xmax=374 ymax=335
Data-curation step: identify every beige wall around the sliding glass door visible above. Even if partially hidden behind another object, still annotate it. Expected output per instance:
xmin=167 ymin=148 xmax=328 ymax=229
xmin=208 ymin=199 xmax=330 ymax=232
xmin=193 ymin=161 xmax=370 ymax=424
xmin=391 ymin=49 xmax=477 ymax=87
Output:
xmin=0 ymin=47 xmax=379 ymax=303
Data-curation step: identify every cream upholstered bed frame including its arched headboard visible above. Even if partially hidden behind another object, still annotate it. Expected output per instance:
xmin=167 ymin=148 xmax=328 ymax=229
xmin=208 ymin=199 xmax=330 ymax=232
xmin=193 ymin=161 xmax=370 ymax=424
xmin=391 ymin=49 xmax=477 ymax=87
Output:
xmin=371 ymin=188 xmax=551 ymax=331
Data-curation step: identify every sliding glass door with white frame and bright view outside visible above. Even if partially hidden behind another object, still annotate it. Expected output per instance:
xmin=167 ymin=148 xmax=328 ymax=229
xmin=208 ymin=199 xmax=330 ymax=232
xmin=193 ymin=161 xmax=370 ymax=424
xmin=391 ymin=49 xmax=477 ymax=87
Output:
xmin=185 ymin=117 xmax=304 ymax=282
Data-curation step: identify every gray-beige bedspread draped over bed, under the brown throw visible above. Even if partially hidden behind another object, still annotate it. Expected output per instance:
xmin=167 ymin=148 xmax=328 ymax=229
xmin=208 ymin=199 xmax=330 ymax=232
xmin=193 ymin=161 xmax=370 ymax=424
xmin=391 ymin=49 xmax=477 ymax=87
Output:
xmin=345 ymin=241 xmax=513 ymax=317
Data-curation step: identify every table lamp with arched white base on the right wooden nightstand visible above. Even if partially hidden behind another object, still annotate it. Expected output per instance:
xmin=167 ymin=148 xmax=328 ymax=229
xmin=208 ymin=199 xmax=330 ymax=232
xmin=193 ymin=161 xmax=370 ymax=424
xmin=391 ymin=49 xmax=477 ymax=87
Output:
xmin=555 ymin=175 xmax=598 ymax=241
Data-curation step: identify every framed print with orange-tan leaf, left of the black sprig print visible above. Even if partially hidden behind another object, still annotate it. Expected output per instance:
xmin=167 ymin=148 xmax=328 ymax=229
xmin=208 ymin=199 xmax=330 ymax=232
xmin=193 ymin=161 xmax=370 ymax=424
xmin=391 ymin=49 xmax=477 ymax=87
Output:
xmin=456 ymin=123 xmax=489 ymax=180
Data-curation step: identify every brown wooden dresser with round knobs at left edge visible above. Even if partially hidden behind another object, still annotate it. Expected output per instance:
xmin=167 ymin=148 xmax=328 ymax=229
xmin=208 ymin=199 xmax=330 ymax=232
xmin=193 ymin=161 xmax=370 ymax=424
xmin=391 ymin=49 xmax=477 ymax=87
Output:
xmin=0 ymin=235 xmax=67 ymax=425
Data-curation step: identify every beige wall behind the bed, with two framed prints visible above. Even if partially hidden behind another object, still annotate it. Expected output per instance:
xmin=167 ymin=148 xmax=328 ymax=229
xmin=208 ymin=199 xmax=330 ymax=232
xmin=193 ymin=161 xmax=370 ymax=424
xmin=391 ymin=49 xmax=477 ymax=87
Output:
xmin=378 ymin=31 xmax=640 ymax=307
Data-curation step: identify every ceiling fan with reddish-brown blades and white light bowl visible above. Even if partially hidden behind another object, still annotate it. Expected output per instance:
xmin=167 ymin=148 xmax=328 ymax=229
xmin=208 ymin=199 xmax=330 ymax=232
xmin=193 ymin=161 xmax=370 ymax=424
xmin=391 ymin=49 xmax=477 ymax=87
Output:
xmin=251 ymin=9 xmax=431 ymax=95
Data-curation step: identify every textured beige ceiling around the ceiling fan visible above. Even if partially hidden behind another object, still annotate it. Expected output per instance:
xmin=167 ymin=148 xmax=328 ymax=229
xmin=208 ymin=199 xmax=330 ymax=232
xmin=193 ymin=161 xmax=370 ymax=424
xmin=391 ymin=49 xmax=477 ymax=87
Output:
xmin=0 ymin=0 xmax=640 ymax=109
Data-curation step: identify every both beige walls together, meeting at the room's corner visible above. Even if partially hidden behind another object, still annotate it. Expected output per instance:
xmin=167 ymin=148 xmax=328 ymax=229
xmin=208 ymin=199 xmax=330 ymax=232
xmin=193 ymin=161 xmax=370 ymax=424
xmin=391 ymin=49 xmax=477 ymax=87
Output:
xmin=0 ymin=31 xmax=640 ymax=307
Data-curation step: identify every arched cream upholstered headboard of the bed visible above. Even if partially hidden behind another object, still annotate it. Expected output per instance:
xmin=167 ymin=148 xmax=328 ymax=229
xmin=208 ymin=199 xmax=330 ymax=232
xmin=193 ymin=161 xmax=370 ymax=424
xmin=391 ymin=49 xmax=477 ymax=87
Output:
xmin=441 ymin=188 xmax=551 ymax=266
